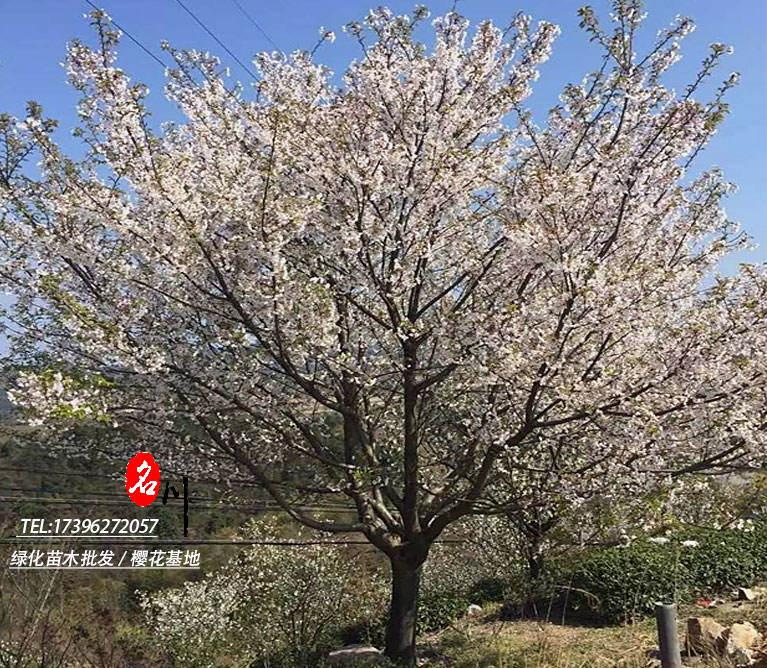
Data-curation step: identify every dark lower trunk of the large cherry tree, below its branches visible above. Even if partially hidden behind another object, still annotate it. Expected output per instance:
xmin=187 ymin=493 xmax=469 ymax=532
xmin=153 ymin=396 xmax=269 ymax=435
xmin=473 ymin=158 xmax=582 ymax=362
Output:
xmin=384 ymin=555 xmax=423 ymax=668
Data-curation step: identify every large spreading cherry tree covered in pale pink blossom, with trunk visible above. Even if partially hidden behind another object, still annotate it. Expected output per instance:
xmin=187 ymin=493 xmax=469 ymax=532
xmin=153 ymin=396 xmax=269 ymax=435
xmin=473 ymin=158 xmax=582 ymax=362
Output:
xmin=0 ymin=0 xmax=767 ymax=665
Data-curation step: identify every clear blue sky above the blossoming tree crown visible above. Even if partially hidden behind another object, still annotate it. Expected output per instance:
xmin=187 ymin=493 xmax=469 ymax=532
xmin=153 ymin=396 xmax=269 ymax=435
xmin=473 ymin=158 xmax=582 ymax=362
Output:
xmin=0 ymin=0 xmax=767 ymax=271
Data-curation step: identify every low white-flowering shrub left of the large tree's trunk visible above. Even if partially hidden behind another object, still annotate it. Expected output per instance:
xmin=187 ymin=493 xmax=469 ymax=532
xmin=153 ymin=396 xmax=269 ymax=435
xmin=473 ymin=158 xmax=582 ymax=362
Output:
xmin=140 ymin=522 xmax=385 ymax=668
